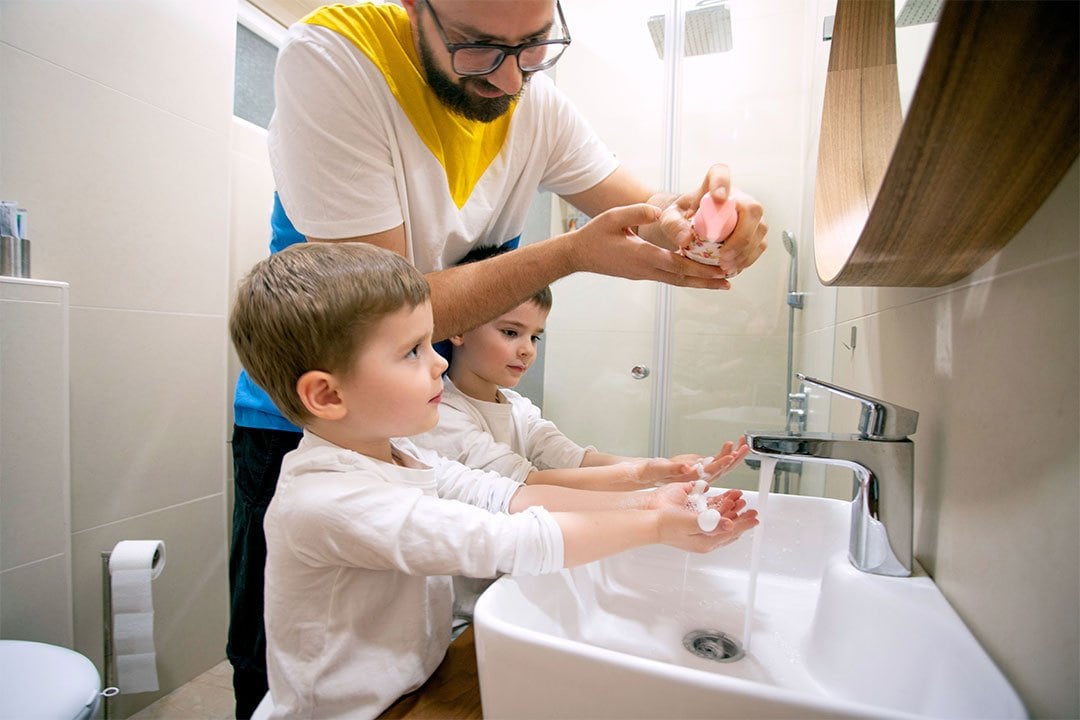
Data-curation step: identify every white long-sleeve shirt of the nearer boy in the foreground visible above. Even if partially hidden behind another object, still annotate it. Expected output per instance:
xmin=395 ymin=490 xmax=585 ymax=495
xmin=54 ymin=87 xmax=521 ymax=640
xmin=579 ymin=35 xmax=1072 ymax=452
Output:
xmin=265 ymin=432 xmax=564 ymax=718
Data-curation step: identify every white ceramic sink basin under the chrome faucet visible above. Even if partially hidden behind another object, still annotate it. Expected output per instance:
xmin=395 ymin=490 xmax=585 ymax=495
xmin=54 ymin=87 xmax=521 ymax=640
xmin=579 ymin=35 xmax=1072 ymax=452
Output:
xmin=474 ymin=492 xmax=1027 ymax=719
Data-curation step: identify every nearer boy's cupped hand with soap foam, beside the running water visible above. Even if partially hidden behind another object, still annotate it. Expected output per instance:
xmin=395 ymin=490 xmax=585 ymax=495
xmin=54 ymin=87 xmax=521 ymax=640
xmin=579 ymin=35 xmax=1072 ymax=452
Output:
xmin=650 ymin=483 xmax=758 ymax=553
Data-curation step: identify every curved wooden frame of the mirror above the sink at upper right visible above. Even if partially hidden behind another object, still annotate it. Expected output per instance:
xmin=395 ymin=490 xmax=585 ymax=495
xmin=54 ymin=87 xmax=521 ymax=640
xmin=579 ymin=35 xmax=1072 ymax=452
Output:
xmin=814 ymin=0 xmax=1080 ymax=287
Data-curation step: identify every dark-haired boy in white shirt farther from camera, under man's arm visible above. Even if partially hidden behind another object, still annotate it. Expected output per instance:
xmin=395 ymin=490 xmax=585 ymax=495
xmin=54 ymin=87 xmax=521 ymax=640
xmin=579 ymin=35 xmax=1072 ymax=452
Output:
xmin=413 ymin=247 xmax=748 ymax=490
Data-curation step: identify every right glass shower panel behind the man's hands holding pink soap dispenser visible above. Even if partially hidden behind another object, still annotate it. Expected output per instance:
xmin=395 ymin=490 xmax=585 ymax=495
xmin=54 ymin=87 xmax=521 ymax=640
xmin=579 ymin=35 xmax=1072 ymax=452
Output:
xmin=664 ymin=0 xmax=821 ymax=488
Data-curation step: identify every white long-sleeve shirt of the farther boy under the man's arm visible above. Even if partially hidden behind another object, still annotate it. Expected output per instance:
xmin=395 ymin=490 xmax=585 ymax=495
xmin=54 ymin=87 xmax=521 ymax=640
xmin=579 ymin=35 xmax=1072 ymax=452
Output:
xmin=413 ymin=378 xmax=595 ymax=483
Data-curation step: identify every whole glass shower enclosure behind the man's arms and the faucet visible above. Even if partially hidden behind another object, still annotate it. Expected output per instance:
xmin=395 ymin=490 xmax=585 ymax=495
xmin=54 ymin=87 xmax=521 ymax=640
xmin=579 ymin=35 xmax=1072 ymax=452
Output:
xmin=543 ymin=0 xmax=835 ymax=494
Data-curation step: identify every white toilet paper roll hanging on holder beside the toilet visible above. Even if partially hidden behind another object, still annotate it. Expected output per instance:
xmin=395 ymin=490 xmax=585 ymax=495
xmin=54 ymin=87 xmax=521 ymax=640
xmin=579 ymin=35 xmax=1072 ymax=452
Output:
xmin=109 ymin=540 xmax=165 ymax=693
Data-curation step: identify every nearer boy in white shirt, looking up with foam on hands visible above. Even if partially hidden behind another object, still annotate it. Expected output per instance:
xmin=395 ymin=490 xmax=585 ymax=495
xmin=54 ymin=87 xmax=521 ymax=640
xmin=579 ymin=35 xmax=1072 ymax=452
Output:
xmin=229 ymin=243 xmax=757 ymax=718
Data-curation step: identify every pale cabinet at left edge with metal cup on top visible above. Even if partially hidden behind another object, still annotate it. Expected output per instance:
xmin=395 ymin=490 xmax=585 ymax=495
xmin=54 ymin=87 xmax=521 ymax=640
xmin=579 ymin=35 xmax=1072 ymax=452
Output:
xmin=0 ymin=277 xmax=75 ymax=648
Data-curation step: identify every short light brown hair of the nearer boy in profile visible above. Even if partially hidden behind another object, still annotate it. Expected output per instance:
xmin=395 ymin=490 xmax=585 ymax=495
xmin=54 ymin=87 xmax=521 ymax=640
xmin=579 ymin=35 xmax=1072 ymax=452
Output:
xmin=229 ymin=243 xmax=431 ymax=425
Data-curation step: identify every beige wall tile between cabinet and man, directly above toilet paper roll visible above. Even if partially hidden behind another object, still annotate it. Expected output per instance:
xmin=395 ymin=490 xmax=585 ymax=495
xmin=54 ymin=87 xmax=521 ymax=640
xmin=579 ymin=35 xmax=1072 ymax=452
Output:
xmin=71 ymin=308 xmax=227 ymax=531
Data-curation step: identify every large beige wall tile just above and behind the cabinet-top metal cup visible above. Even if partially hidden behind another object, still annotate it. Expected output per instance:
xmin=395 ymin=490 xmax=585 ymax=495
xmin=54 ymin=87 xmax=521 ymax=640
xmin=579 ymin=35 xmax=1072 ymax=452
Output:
xmin=0 ymin=47 xmax=228 ymax=314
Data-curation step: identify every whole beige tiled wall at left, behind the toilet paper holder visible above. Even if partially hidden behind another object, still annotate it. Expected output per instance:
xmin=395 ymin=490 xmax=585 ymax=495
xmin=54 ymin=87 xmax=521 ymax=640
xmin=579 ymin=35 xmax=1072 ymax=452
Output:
xmin=0 ymin=0 xmax=235 ymax=717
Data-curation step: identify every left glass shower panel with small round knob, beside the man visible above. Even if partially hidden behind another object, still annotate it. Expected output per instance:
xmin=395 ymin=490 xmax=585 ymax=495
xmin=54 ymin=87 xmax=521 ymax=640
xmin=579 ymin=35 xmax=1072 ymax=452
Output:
xmin=543 ymin=0 xmax=667 ymax=456
